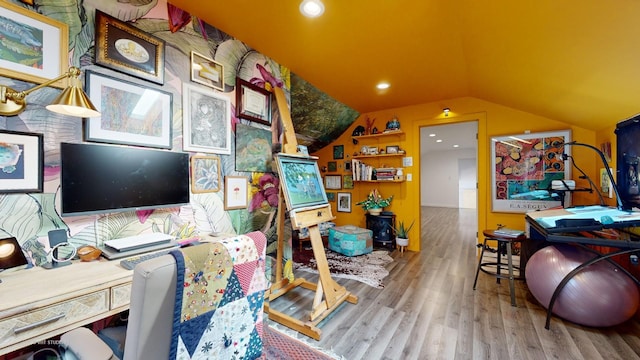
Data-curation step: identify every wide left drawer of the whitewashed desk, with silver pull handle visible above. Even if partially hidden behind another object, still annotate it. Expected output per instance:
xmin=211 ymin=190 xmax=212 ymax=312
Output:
xmin=0 ymin=289 xmax=109 ymax=347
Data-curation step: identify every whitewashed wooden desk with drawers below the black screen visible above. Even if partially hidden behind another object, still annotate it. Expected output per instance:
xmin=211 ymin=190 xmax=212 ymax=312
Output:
xmin=0 ymin=234 xmax=235 ymax=355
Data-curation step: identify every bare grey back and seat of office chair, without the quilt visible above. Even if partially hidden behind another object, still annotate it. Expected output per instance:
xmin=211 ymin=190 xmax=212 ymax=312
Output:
xmin=60 ymin=255 xmax=177 ymax=360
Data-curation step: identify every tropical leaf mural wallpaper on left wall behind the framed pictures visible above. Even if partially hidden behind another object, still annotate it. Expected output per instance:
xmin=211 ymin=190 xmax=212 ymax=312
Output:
xmin=0 ymin=0 xmax=357 ymax=278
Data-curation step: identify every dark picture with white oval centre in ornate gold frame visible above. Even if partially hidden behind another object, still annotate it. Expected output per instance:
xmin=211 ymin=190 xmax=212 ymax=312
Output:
xmin=95 ymin=10 xmax=165 ymax=85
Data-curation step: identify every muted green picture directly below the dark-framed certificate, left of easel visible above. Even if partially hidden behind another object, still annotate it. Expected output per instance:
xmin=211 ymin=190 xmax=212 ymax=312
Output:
xmin=235 ymin=124 xmax=273 ymax=172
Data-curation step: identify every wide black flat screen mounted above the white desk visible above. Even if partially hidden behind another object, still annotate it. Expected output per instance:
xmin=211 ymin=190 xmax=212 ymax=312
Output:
xmin=60 ymin=143 xmax=189 ymax=216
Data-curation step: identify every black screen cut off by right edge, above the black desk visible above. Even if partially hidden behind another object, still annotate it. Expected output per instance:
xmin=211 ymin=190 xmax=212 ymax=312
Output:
xmin=615 ymin=115 xmax=640 ymax=210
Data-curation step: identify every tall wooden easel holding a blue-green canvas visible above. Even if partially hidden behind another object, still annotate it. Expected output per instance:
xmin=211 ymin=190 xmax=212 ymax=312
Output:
xmin=264 ymin=88 xmax=358 ymax=340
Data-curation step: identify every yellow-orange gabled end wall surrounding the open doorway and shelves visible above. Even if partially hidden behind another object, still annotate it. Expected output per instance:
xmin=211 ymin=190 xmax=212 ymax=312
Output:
xmin=313 ymin=97 xmax=612 ymax=251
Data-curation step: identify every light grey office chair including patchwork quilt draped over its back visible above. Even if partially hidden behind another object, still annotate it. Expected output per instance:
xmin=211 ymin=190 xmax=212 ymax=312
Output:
xmin=60 ymin=231 xmax=268 ymax=360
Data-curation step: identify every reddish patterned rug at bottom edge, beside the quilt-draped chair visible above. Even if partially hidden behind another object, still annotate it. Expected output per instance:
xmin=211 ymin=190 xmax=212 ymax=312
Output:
xmin=260 ymin=326 xmax=342 ymax=360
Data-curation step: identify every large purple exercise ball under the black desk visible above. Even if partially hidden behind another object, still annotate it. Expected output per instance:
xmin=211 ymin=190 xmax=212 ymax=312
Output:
xmin=525 ymin=244 xmax=640 ymax=327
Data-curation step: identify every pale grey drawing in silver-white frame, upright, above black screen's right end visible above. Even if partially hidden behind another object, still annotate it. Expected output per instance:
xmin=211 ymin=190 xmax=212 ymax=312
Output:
xmin=182 ymin=83 xmax=231 ymax=154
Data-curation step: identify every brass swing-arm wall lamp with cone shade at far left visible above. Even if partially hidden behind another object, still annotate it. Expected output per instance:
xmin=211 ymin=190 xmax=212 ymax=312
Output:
xmin=0 ymin=66 xmax=100 ymax=117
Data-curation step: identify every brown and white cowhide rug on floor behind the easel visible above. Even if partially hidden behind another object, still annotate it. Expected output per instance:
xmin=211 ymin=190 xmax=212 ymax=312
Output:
xmin=293 ymin=249 xmax=393 ymax=289
